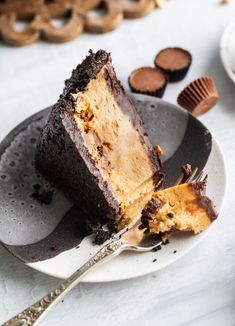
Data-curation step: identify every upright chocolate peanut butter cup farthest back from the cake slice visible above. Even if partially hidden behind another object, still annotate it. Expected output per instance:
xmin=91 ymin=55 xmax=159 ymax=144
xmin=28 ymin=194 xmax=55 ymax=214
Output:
xmin=154 ymin=47 xmax=192 ymax=82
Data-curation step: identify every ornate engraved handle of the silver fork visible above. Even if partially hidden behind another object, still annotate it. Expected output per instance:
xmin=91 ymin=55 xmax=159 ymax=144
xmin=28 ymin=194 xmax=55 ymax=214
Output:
xmin=2 ymin=239 xmax=127 ymax=326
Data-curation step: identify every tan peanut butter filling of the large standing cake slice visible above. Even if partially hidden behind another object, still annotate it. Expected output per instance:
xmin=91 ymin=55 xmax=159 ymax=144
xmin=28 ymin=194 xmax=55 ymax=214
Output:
xmin=73 ymin=70 xmax=154 ymax=215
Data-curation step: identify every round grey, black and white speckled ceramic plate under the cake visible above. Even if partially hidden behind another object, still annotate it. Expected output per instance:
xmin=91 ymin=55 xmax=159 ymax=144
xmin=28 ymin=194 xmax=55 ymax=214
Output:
xmin=0 ymin=95 xmax=226 ymax=282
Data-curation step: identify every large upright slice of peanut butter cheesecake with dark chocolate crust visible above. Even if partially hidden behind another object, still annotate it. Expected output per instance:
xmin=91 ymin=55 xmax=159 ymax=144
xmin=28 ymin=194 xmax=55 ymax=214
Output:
xmin=35 ymin=50 xmax=162 ymax=227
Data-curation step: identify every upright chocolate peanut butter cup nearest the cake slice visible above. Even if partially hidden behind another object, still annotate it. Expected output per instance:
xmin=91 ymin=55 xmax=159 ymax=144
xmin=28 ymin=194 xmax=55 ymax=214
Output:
xmin=128 ymin=67 xmax=167 ymax=98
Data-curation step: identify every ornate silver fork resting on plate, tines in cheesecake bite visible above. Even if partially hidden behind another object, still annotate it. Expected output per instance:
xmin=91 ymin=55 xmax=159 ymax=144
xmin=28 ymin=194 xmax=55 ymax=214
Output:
xmin=2 ymin=168 xmax=205 ymax=326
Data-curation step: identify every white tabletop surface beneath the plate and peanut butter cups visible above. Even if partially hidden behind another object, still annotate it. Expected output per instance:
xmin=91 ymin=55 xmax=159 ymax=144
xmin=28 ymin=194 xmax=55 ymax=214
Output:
xmin=0 ymin=0 xmax=235 ymax=326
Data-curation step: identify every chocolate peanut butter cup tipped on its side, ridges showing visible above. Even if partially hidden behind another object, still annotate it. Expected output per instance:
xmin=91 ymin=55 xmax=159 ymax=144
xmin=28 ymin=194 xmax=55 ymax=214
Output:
xmin=177 ymin=76 xmax=219 ymax=116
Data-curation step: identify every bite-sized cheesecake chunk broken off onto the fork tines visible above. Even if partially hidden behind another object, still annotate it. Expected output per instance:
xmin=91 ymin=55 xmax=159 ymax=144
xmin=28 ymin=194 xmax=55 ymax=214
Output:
xmin=141 ymin=180 xmax=217 ymax=234
